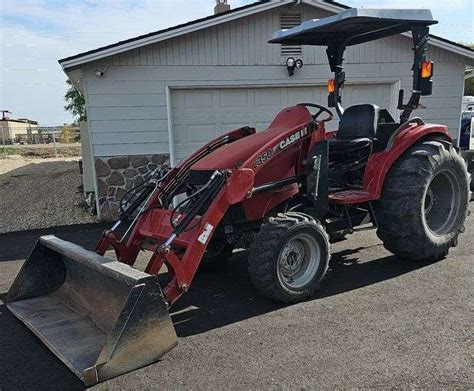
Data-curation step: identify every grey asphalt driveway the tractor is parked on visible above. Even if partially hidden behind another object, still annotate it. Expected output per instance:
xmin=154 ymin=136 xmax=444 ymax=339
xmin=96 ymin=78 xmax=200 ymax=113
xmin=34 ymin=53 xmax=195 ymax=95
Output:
xmin=0 ymin=211 xmax=474 ymax=390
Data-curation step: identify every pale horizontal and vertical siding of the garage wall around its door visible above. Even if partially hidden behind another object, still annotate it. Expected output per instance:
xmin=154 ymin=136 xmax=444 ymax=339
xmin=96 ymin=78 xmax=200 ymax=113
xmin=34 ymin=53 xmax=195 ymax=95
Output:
xmin=83 ymin=6 xmax=464 ymax=156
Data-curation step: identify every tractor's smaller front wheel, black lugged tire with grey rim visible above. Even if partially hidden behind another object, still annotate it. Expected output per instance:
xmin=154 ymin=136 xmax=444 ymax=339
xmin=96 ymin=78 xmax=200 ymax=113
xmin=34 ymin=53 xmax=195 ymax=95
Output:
xmin=249 ymin=212 xmax=330 ymax=304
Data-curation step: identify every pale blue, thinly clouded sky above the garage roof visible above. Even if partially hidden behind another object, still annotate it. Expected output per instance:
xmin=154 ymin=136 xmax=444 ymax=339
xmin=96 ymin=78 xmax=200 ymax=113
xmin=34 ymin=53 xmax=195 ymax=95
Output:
xmin=0 ymin=0 xmax=474 ymax=126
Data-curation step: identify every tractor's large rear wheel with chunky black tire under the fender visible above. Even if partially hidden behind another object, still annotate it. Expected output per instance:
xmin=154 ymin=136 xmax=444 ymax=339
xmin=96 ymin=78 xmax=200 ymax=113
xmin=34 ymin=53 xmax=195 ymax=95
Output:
xmin=375 ymin=139 xmax=469 ymax=261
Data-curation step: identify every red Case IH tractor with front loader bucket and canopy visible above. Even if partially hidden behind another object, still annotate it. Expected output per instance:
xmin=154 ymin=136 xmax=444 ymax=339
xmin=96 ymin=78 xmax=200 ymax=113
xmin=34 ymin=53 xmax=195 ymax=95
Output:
xmin=6 ymin=9 xmax=470 ymax=384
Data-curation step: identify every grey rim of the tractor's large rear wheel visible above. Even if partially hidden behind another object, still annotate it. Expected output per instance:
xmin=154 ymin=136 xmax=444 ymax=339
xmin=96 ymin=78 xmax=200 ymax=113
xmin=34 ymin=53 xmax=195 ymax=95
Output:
xmin=423 ymin=170 xmax=460 ymax=235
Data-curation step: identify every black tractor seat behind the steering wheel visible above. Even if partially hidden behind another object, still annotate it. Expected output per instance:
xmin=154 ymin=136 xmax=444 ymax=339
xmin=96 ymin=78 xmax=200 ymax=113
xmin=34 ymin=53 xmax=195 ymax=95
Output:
xmin=329 ymin=104 xmax=380 ymax=153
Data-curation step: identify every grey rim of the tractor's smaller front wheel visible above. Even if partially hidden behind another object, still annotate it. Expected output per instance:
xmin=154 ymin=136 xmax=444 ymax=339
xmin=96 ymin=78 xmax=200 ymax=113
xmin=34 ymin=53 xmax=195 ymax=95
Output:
xmin=278 ymin=233 xmax=321 ymax=289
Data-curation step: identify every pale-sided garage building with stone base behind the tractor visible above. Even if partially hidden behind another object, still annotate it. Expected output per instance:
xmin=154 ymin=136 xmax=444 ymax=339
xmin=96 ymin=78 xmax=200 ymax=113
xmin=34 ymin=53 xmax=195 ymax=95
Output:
xmin=60 ymin=0 xmax=474 ymax=220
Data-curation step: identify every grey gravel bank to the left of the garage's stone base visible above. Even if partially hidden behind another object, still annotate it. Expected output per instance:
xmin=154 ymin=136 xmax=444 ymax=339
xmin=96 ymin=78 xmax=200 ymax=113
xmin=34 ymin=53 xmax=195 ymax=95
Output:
xmin=0 ymin=156 xmax=94 ymax=233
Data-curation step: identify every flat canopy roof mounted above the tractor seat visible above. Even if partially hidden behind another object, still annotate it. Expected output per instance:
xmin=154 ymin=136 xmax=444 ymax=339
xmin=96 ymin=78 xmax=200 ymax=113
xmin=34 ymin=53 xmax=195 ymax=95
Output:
xmin=269 ymin=8 xmax=438 ymax=46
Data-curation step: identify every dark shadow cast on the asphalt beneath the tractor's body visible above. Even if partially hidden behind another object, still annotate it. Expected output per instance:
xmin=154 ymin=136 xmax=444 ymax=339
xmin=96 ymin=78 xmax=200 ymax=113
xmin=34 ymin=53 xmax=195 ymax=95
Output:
xmin=171 ymin=247 xmax=436 ymax=337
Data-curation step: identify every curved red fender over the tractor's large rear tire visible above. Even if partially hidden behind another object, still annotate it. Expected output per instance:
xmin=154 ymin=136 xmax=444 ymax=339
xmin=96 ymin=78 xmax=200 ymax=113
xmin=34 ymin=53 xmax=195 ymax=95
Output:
xmin=364 ymin=123 xmax=452 ymax=200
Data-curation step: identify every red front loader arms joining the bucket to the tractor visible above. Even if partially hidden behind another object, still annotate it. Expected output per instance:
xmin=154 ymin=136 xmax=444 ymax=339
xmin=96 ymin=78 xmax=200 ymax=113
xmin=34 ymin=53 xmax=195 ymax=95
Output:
xmin=96 ymin=127 xmax=255 ymax=304
